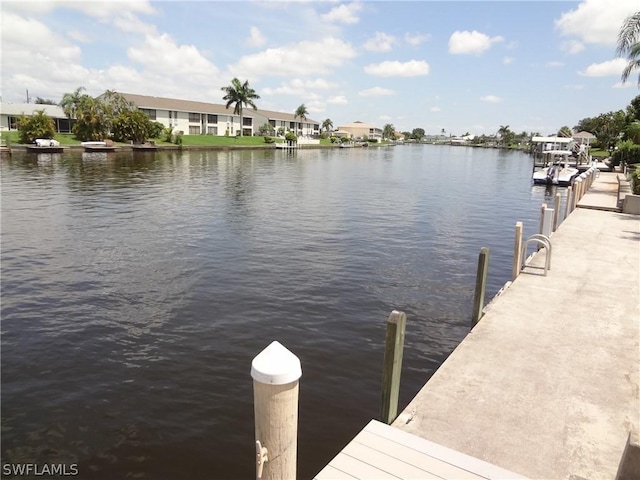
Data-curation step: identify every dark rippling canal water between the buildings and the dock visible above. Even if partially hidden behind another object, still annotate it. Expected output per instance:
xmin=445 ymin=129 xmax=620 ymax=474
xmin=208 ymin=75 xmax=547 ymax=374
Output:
xmin=1 ymin=145 xmax=564 ymax=479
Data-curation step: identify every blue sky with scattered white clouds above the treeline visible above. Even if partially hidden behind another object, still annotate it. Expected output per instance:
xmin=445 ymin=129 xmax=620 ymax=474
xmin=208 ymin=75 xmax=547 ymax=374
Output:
xmin=0 ymin=0 xmax=640 ymax=135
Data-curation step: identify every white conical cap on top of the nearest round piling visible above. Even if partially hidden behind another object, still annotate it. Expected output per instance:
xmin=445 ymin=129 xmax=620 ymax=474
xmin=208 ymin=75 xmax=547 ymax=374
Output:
xmin=251 ymin=342 xmax=302 ymax=385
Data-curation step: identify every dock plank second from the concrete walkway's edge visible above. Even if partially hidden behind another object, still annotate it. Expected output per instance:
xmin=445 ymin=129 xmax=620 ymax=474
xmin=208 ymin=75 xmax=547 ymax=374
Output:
xmin=353 ymin=431 xmax=486 ymax=480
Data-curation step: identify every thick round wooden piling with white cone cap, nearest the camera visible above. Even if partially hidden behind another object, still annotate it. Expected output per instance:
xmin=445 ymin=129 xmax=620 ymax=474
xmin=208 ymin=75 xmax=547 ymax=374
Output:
xmin=251 ymin=342 xmax=302 ymax=480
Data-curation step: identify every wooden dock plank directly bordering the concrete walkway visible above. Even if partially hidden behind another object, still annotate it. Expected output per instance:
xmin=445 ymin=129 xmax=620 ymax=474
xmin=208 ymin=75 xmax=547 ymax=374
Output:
xmin=364 ymin=420 xmax=526 ymax=480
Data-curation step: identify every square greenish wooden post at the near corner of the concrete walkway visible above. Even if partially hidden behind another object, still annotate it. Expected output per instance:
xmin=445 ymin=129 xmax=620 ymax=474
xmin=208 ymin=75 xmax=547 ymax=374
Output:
xmin=380 ymin=310 xmax=407 ymax=424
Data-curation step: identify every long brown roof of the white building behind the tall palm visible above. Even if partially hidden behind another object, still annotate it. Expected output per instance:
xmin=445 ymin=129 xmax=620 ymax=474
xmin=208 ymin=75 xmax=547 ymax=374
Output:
xmin=121 ymin=93 xmax=318 ymax=123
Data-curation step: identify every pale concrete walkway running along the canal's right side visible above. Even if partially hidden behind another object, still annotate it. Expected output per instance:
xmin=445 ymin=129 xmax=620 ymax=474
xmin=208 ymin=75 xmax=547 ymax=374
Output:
xmin=392 ymin=172 xmax=640 ymax=480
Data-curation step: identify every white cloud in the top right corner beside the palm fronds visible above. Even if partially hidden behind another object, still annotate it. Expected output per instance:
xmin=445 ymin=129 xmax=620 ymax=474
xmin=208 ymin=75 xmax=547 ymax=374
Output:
xmin=554 ymin=0 xmax=638 ymax=45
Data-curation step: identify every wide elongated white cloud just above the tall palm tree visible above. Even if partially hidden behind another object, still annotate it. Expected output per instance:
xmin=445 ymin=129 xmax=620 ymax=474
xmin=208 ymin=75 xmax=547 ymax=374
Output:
xmin=229 ymin=38 xmax=356 ymax=78
